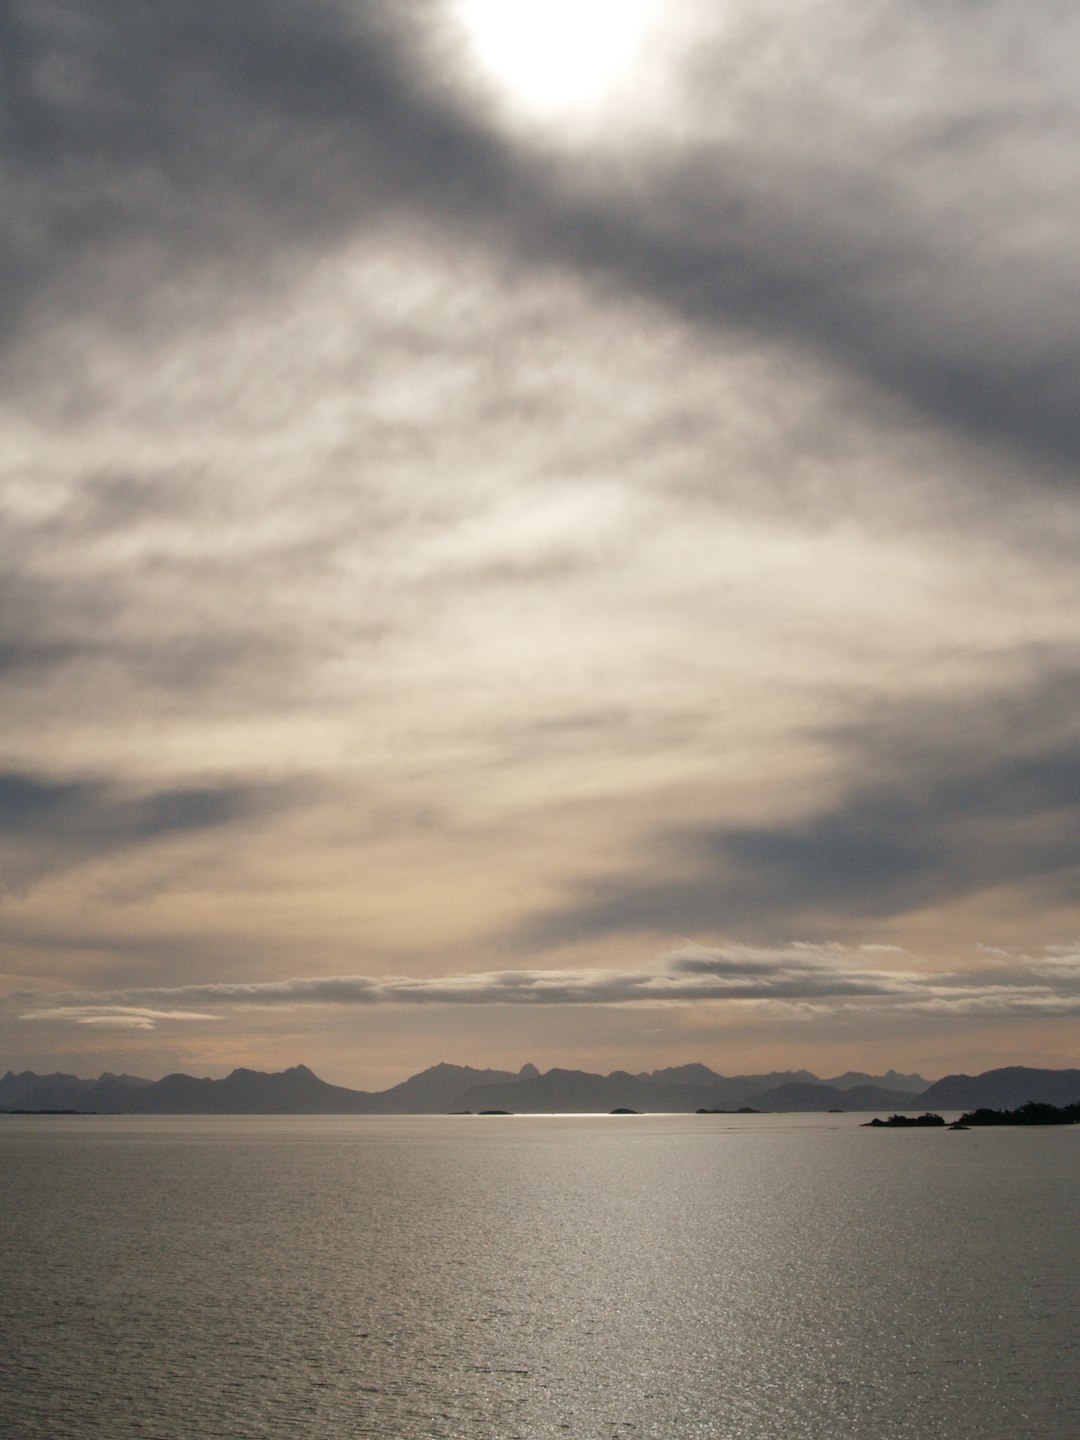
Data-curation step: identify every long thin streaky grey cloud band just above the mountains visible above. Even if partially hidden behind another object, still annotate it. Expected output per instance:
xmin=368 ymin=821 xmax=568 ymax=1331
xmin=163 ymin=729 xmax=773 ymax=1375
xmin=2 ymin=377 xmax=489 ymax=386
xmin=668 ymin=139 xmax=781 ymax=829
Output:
xmin=13 ymin=945 xmax=1080 ymax=1025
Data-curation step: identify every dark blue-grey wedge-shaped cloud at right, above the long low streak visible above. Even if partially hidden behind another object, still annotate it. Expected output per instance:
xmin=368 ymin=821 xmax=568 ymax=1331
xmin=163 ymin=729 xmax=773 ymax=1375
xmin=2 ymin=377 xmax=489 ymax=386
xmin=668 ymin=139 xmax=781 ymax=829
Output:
xmin=526 ymin=671 xmax=1080 ymax=943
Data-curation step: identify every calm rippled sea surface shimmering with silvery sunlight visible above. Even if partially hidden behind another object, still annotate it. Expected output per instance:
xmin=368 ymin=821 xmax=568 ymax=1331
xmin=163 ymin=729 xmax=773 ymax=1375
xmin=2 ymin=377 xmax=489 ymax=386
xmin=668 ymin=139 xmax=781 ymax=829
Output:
xmin=0 ymin=1115 xmax=1080 ymax=1440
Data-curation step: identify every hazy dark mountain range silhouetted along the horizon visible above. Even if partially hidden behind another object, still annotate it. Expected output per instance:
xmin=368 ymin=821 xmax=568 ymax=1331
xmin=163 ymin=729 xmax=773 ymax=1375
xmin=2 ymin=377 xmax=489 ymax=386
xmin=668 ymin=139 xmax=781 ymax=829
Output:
xmin=0 ymin=1064 xmax=1080 ymax=1115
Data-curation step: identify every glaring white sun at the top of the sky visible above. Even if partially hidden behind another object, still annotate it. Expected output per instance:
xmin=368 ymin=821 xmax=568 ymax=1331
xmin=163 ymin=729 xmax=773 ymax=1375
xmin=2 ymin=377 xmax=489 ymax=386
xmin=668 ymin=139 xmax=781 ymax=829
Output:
xmin=456 ymin=0 xmax=657 ymax=118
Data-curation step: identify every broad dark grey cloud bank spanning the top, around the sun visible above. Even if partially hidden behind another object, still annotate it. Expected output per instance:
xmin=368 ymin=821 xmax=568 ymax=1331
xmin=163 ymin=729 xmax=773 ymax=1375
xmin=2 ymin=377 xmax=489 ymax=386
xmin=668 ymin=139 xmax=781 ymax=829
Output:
xmin=8 ymin=0 xmax=1080 ymax=482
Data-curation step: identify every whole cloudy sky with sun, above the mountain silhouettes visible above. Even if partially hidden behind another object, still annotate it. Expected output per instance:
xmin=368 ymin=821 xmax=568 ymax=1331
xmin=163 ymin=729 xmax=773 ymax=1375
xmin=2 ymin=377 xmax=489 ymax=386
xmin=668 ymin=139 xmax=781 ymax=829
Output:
xmin=0 ymin=0 xmax=1080 ymax=1089
